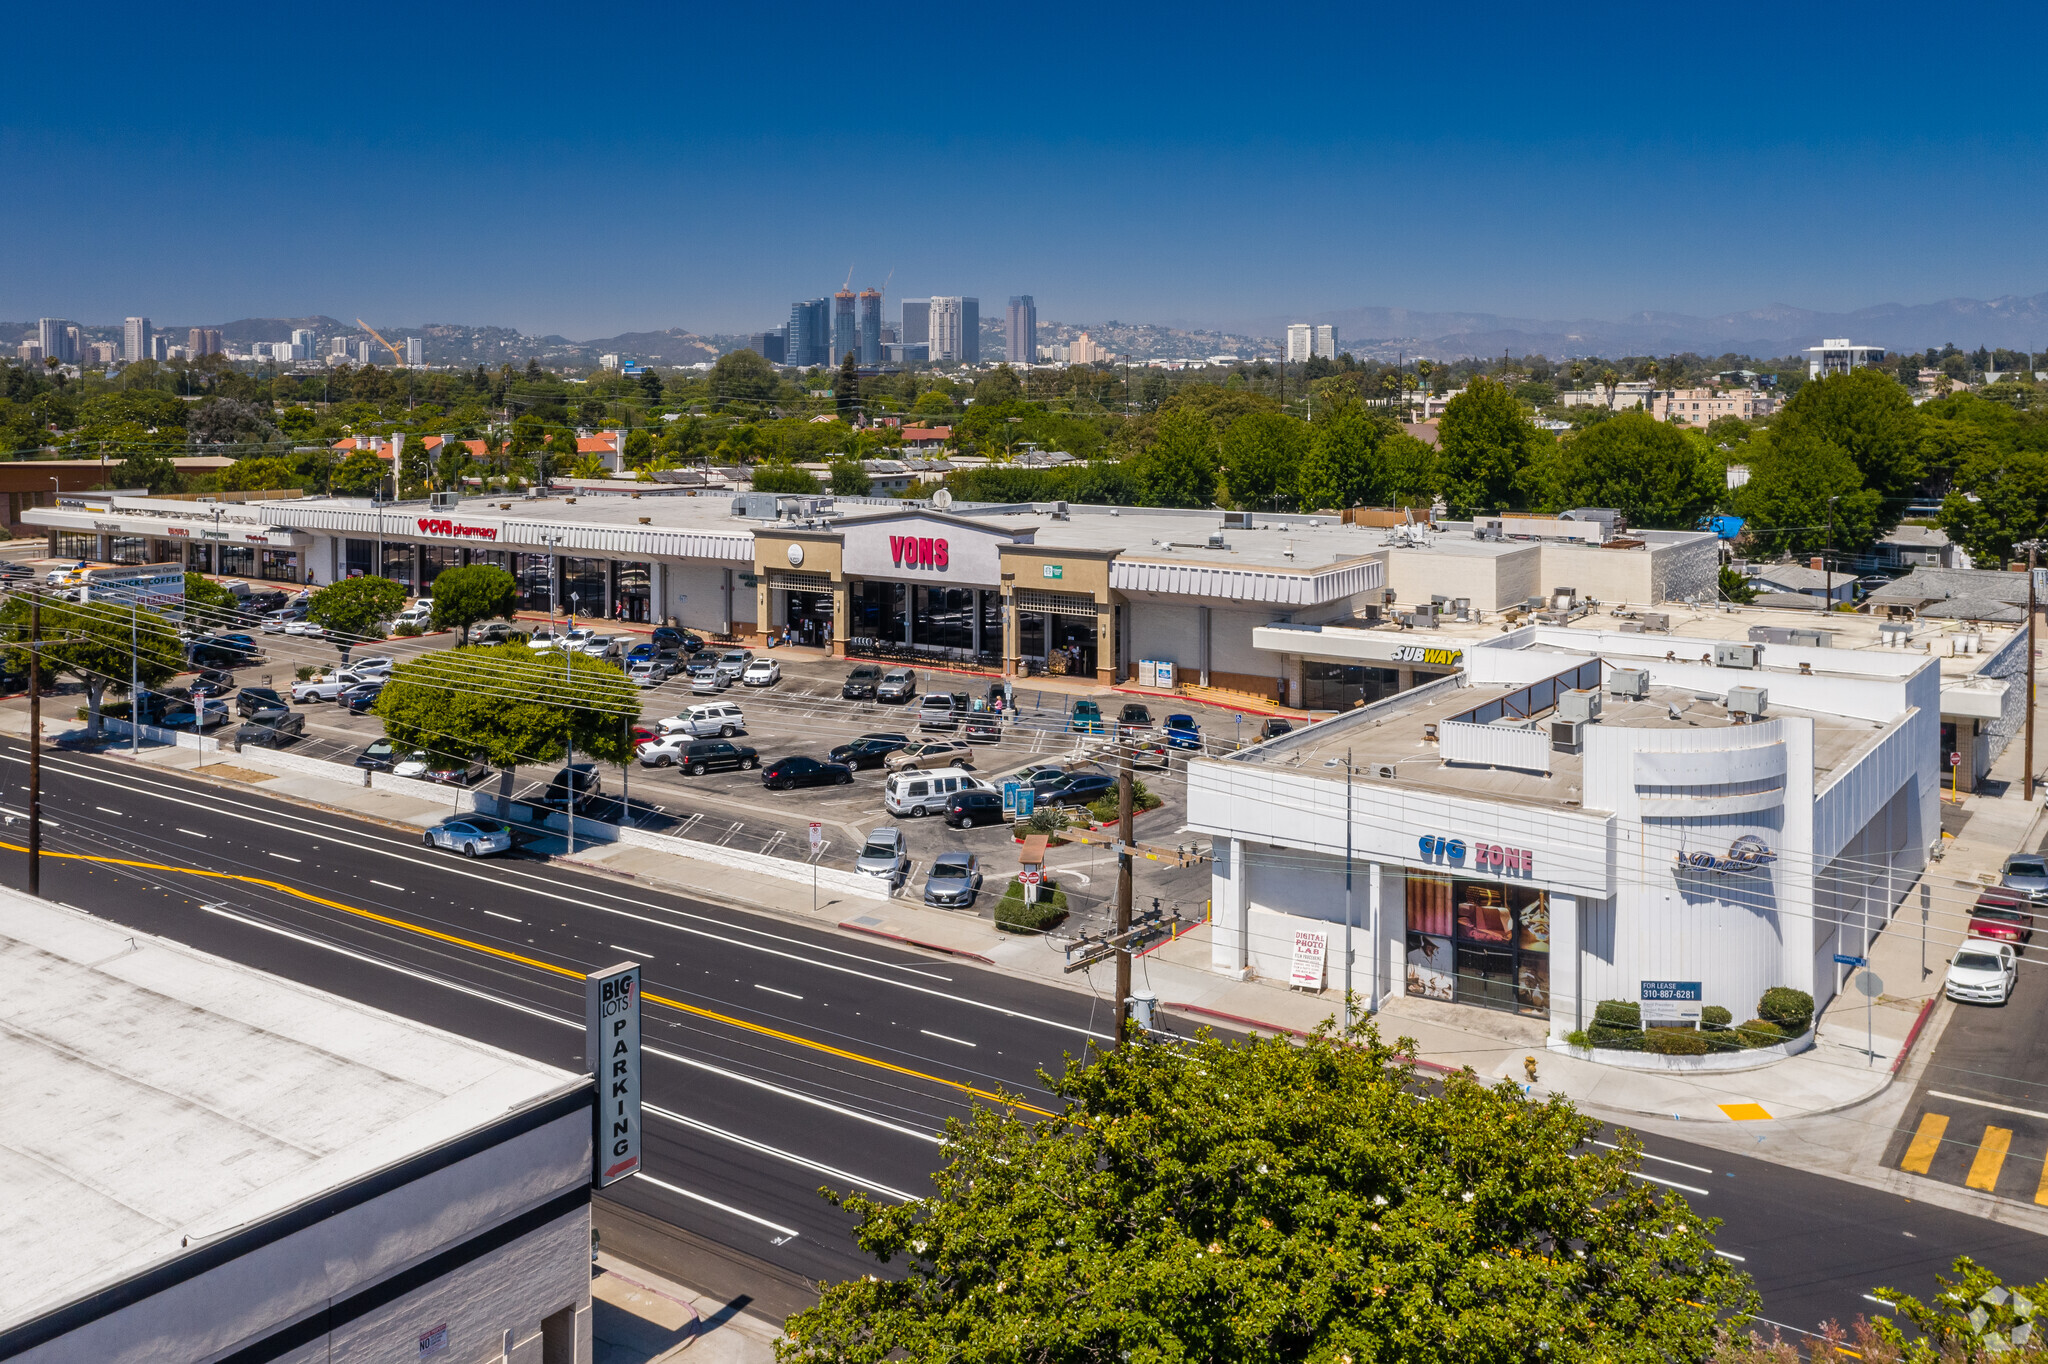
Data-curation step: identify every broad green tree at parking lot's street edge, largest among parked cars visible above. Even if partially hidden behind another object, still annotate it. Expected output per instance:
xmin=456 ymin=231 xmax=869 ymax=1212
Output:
xmin=377 ymin=643 xmax=639 ymax=776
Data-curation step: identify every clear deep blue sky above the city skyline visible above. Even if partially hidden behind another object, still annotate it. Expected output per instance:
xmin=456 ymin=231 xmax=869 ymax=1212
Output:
xmin=0 ymin=4 xmax=2048 ymax=338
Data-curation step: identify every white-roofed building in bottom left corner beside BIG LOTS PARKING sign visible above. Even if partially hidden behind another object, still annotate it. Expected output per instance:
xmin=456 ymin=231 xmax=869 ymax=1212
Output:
xmin=0 ymin=891 xmax=594 ymax=1364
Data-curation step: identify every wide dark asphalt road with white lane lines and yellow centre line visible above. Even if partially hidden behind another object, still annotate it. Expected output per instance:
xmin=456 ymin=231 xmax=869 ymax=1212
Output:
xmin=0 ymin=741 xmax=2048 ymax=1327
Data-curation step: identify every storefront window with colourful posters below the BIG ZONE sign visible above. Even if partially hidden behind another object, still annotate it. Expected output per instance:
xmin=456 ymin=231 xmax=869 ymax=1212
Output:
xmin=1407 ymin=877 xmax=1550 ymax=1014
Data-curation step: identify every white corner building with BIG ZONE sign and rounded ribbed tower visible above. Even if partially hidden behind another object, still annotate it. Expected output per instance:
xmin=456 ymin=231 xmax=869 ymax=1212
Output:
xmin=1188 ymin=606 xmax=2028 ymax=1038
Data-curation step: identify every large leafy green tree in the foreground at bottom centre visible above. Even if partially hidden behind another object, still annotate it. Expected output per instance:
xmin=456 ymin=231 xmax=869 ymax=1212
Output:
xmin=778 ymin=1024 xmax=1757 ymax=1364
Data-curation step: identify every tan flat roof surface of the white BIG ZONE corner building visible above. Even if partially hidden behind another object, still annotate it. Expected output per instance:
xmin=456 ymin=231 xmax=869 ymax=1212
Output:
xmin=1223 ymin=659 xmax=1896 ymax=809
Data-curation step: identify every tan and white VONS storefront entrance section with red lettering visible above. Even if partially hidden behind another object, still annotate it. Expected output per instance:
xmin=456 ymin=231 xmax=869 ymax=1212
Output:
xmin=752 ymin=510 xmax=1116 ymax=682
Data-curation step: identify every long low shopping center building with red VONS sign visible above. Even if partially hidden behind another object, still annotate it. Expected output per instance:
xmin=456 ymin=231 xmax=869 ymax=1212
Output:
xmin=25 ymin=485 xmax=1718 ymax=711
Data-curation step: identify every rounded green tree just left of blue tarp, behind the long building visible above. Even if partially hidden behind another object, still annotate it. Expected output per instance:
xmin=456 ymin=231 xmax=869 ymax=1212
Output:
xmin=1559 ymin=412 xmax=1726 ymax=530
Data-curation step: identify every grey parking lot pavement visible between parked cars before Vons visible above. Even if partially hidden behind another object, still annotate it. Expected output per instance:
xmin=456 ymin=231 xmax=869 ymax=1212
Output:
xmin=172 ymin=635 xmax=1228 ymax=926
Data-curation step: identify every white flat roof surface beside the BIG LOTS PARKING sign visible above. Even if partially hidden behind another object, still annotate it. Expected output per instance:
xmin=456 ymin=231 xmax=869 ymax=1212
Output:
xmin=0 ymin=891 xmax=586 ymax=1327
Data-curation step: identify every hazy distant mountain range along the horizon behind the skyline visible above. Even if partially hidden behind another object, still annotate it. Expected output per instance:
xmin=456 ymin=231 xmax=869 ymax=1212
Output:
xmin=16 ymin=293 xmax=2048 ymax=369
